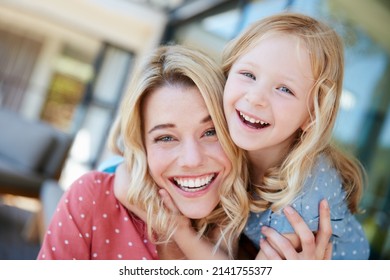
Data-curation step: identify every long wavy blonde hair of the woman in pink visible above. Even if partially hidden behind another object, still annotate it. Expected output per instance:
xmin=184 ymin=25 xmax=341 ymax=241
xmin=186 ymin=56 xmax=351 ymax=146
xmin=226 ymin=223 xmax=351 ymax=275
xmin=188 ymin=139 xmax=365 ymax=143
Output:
xmin=109 ymin=46 xmax=249 ymax=257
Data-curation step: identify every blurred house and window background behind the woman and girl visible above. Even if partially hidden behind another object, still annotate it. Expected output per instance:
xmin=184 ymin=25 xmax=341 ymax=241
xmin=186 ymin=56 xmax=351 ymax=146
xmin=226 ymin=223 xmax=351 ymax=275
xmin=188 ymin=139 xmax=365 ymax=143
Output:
xmin=0 ymin=0 xmax=390 ymax=259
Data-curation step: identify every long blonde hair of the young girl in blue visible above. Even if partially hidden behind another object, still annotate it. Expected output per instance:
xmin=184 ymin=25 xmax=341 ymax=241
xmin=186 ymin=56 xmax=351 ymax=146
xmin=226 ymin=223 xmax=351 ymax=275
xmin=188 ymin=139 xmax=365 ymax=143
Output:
xmin=222 ymin=12 xmax=364 ymax=213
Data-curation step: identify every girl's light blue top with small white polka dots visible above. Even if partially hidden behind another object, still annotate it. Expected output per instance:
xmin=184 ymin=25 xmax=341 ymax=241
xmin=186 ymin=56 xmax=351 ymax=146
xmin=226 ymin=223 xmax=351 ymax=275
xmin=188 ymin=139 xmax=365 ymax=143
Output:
xmin=244 ymin=156 xmax=370 ymax=260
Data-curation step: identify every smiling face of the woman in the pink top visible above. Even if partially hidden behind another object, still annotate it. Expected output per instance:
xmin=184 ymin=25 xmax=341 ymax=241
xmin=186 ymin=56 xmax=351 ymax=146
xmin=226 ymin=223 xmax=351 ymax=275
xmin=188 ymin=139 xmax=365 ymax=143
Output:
xmin=142 ymin=86 xmax=231 ymax=219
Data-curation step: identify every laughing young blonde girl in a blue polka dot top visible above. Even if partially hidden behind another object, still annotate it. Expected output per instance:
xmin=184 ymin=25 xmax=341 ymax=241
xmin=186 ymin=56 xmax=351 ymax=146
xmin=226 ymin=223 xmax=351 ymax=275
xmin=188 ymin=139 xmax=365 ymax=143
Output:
xmin=223 ymin=13 xmax=369 ymax=259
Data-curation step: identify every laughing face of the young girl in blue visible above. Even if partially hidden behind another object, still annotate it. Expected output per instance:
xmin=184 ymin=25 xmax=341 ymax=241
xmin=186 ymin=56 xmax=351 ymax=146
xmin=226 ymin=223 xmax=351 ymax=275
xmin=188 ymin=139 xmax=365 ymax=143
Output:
xmin=224 ymin=34 xmax=314 ymax=156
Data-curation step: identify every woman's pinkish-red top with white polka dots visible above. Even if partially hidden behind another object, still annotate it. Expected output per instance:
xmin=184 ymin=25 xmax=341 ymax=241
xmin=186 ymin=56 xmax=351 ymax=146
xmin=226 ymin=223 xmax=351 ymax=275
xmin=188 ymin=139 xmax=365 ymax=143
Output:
xmin=37 ymin=171 xmax=158 ymax=260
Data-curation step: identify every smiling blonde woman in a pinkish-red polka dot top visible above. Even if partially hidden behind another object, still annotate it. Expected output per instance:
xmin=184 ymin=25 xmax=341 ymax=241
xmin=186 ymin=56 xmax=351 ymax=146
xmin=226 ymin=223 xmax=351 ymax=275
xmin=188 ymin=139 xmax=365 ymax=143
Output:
xmin=38 ymin=46 xmax=249 ymax=259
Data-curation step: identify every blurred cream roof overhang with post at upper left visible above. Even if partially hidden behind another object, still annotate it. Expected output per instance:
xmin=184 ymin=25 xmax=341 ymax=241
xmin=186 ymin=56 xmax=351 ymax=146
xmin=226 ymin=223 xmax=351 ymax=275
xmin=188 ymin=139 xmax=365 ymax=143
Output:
xmin=0 ymin=0 xmax=167 ymax=118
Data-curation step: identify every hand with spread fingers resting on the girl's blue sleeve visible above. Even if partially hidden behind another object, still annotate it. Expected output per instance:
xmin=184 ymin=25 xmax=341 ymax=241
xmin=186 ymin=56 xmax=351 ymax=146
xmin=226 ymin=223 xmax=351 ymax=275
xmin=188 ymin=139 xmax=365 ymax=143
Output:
xmin=256 ymin=200 xmax=332 ymax=260
